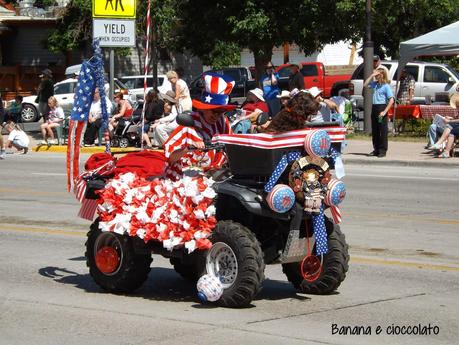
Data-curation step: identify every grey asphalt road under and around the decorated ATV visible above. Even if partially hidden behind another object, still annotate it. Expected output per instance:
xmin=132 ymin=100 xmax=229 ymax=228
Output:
xmin=0 ymin=153 xmax=459 ymax=345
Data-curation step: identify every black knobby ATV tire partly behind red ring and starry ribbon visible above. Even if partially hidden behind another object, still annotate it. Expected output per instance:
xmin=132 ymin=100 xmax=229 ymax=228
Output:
xmin=282 ymin=219 xmax=349 ymax=295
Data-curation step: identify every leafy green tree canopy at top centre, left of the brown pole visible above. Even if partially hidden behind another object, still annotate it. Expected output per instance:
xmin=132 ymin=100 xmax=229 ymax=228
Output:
xmin=175 ymin=0 xmax=362 ymax=79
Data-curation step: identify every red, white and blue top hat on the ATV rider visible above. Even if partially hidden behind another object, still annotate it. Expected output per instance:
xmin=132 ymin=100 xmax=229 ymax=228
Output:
xmin=193 ymin=73 xmax=236 ymax=110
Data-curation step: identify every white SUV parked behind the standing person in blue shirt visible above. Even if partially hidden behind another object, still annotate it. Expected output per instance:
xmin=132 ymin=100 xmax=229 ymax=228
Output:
xmin=349 ymin=60 xmax=459 ymax=109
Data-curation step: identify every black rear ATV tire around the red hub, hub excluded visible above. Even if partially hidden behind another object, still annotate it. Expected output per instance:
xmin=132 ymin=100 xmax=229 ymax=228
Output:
xmin=85 ymin=221 xmax=152 ymax=293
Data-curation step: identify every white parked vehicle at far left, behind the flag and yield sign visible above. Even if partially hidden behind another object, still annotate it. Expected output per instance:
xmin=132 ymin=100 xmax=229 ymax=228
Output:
xmin=14 ymin=78 xmax=131 ymax=122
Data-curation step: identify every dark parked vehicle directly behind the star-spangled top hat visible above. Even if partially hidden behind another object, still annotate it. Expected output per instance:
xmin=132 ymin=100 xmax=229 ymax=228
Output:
xmin=190 ymin=67 xmax=256 ymax=103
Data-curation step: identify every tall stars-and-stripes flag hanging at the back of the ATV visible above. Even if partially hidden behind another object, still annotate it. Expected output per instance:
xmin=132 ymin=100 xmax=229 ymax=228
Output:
xmin=67 ymin=61 xmax=96 ymax=191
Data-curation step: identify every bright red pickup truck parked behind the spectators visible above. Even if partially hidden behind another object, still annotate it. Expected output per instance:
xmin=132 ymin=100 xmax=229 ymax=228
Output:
xmin=276 ymin=62 xmax=351 ymax=97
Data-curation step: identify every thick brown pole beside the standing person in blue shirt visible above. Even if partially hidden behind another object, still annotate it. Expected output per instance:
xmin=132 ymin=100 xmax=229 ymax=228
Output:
xmin=363 ymin=0 xmax=374 ymax=134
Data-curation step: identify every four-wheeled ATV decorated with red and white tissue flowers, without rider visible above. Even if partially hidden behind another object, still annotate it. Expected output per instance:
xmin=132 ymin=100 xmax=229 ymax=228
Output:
xmin=86 ymin=123 xmax=349 ymax=308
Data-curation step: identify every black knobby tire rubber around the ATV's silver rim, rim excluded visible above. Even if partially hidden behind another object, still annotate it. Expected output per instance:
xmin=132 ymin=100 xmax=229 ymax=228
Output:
xmin=206 ymin=221 xmax=265 ymax=308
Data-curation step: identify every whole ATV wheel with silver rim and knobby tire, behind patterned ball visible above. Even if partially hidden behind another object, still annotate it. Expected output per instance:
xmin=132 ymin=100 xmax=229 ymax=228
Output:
xmin=206 ymin=221 xmax=265 ymax=308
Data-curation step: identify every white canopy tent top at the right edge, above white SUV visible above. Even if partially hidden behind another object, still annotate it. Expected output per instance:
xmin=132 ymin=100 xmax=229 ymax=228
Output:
xmin=398 ymin=21 xmax=459 ymax=77
